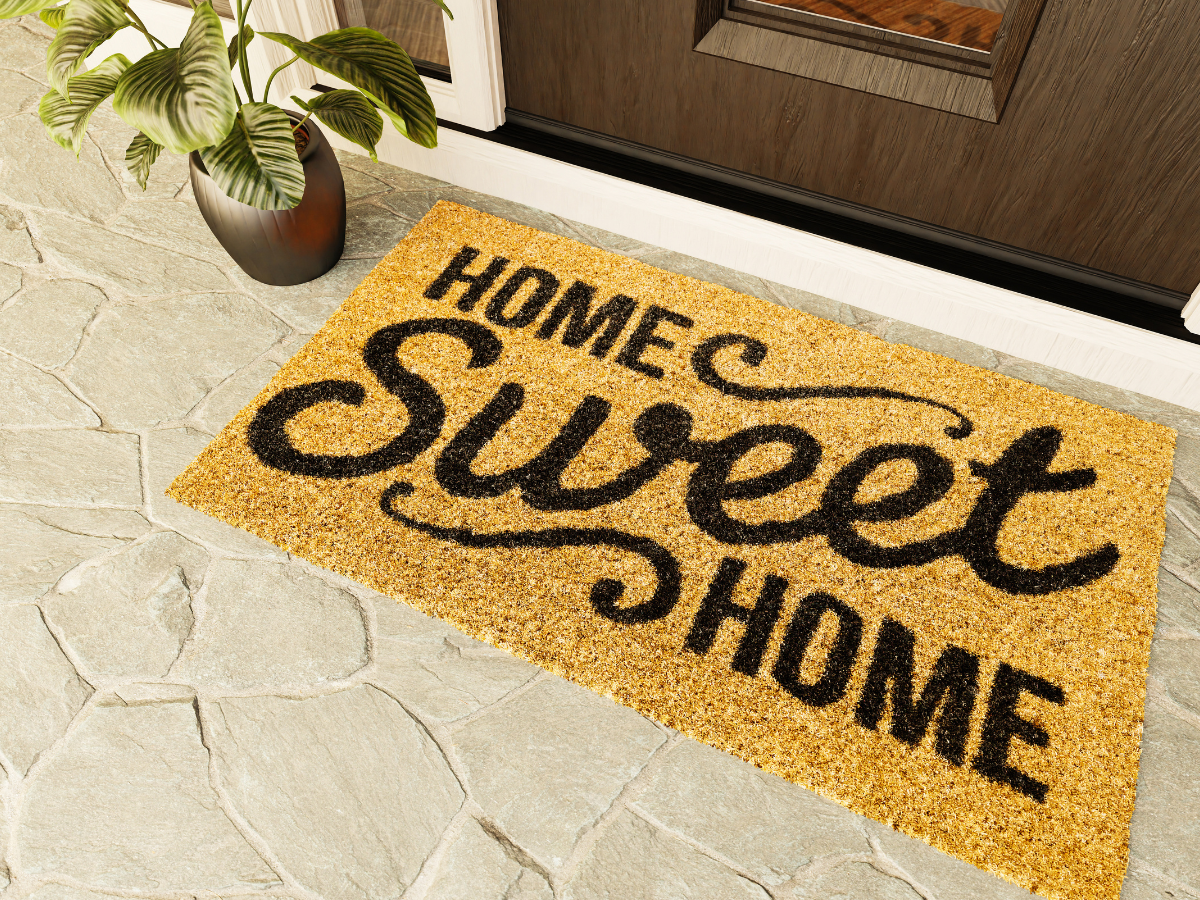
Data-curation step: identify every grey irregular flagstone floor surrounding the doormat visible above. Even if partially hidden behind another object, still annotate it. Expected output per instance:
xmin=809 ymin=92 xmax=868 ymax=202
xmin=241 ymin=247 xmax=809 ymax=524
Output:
xmin=0 ymin=19 xmax=1200 ymax=900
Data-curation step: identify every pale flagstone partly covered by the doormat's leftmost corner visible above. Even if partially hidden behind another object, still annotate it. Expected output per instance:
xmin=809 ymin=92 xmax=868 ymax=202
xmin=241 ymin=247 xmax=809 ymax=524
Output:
xmin=146 ymin=428 xmax=287 ymax=559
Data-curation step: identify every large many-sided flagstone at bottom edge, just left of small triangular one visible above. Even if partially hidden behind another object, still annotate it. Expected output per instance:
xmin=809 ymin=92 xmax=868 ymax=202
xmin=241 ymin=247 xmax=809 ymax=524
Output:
xmin=203 ymin=685 xmax=463 ymax=900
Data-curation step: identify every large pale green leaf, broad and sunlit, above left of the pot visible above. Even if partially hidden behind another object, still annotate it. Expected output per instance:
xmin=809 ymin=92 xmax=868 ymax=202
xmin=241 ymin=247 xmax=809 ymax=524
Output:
xmin=113 ymin=0 xmax=238 ymax=154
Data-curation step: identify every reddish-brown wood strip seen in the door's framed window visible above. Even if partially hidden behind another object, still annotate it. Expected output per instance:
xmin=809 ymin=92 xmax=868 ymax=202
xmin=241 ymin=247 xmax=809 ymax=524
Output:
xmin=758 ymin=0 xmax=1003 ymax=50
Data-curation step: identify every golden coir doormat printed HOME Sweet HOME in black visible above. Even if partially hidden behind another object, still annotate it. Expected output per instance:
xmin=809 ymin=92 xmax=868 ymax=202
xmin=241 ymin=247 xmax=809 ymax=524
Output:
xmin=170 ymin=203 xmax=1175 ymax=900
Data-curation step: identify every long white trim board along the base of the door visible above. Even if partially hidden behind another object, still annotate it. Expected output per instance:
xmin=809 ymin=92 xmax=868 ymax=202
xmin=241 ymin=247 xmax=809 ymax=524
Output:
xmin=316 ymin=114 xmax=1200 ymax=412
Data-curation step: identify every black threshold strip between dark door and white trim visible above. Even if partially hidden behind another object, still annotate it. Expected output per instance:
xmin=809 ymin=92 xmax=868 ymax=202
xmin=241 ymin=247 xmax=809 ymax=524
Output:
xmin=438 ymin=109 xmax=1200 ymax=343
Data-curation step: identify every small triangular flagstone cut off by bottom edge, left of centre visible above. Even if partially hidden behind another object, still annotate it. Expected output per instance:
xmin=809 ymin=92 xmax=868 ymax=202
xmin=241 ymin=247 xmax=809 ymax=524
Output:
xmin=425 ymin=820 xmax=554 ymax=900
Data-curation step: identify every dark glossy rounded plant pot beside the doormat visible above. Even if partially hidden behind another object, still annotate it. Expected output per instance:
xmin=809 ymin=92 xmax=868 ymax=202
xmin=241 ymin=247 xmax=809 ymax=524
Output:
xmin=191 ymin=112 xmax=346 ymax=284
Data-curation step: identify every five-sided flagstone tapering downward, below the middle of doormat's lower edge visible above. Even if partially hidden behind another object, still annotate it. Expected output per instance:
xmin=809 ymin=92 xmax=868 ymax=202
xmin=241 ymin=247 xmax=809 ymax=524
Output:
xmin=455 ymin=678 xmax=667 ymax=869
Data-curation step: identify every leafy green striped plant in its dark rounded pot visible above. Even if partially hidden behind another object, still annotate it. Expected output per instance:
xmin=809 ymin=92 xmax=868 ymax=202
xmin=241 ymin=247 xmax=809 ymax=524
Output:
xmin=0 ymin=0 xmax=452 ymax=284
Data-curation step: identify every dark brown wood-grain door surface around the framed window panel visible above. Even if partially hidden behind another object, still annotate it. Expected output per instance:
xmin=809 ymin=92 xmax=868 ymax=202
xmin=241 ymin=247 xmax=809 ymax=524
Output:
xmin=499 ymin=0 xmax=1200 ymax=293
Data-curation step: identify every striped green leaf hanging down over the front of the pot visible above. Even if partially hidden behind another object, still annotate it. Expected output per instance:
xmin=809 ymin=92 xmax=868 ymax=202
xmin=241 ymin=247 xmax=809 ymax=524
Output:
xmin=200 ymin=103 xmax=304 ymax=209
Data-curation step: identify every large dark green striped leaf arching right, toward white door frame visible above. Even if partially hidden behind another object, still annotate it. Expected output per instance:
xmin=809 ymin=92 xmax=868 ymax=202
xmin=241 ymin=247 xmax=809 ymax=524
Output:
xmin=259 ymin=28 xmax=438 ymax=148
